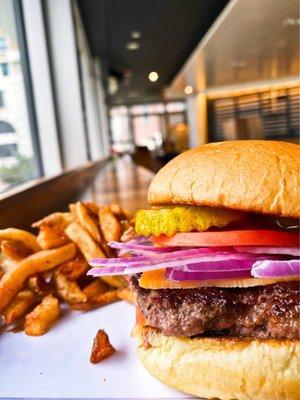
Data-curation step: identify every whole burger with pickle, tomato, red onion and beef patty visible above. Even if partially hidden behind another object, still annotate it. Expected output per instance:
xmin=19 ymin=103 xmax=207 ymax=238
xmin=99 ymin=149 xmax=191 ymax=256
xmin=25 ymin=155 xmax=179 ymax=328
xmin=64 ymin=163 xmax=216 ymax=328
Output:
xmin=91 ymin=141 xmax=300 ymax=400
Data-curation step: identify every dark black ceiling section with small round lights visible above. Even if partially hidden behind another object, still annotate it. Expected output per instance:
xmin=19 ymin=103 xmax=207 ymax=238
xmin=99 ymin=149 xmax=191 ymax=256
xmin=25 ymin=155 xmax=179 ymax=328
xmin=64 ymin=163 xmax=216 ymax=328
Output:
xmin=78 ymin=0 xmax=228 ymax=104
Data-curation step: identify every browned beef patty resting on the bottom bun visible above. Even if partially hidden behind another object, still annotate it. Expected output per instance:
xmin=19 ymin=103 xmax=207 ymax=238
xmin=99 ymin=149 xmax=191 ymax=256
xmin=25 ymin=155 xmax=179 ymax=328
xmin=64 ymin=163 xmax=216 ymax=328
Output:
xmin=131 ymin=277 xmax=300 ymax=339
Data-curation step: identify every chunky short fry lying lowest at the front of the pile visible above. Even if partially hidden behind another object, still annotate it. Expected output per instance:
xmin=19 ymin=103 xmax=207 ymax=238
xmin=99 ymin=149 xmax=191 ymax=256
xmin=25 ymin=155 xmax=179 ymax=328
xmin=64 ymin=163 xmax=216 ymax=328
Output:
xmin=25 ymin=295 xmax=60 ymax=336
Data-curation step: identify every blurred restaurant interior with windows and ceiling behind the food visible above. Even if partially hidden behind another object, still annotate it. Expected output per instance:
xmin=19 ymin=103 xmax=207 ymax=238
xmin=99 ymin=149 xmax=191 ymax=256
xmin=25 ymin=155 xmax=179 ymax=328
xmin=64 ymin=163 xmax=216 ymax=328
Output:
xmin=0 ymin=0 xmax=300 ymax=192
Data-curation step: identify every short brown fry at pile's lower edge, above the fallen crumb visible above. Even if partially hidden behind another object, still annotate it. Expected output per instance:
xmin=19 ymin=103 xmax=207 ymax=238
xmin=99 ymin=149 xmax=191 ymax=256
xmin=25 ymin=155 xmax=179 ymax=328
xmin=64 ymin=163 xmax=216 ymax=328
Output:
xmin=53 ymin=270 xmax=87 ymax=304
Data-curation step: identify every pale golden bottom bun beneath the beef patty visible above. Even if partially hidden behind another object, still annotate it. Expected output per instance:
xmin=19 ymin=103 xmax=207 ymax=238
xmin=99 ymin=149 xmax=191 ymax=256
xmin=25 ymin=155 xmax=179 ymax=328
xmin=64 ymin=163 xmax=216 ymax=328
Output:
xmin=133 ymin=326 xmax=300 ymax=400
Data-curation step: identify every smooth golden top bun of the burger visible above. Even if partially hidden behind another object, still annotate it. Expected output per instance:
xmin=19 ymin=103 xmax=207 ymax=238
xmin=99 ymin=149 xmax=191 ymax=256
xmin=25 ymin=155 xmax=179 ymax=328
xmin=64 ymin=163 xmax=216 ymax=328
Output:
xmin=148 ymin=140 xmax=300 ymax=218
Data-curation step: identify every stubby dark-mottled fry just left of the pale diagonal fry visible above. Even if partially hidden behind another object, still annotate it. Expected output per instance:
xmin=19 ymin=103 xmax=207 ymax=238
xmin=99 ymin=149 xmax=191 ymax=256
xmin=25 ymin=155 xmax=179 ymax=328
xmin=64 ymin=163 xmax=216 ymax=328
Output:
xmin=37 ymin=224 xmax=70 ymax=250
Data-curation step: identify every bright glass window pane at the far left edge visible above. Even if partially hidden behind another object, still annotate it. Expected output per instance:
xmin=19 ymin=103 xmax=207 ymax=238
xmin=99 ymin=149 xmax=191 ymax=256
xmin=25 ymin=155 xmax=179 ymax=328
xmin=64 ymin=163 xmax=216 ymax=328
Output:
xmin=0 ymin=0 xmax=39 ymax=192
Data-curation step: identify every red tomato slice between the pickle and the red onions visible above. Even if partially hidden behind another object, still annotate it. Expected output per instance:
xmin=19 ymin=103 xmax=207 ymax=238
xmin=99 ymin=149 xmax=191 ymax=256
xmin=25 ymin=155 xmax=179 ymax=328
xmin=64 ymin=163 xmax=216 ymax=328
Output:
xmin=152 ymin=230 xmax=299 ymax=247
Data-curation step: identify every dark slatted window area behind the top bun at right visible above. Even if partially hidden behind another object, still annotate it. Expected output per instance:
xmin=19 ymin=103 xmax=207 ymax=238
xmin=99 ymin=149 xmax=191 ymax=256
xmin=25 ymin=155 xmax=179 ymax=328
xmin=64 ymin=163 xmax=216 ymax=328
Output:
xmin=209 ymin=87 xmax=300 ymax=141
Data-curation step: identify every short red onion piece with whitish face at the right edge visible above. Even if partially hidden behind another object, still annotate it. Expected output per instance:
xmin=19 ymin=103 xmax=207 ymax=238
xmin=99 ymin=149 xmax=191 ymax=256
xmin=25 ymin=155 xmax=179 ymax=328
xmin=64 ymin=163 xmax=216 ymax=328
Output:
xmin=251 ymin=260 xmax=300 ymax=278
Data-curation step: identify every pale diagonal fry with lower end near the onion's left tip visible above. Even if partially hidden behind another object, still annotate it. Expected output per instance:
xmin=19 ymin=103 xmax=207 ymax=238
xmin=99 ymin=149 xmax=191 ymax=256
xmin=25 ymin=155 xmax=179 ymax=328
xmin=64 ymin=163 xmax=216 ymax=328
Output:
xmin=65 ymin=222 xmax=105 ymax=261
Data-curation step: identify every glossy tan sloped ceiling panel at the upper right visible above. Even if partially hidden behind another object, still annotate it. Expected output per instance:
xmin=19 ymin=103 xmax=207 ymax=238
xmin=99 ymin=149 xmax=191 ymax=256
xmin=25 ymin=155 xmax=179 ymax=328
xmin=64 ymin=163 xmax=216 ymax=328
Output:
xmin=167 ymin=0 xmax=300 ymax=97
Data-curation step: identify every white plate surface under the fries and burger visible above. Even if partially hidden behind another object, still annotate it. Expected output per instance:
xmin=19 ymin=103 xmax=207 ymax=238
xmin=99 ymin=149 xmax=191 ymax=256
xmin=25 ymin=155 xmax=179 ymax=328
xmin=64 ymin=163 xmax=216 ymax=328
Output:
xmin=0 ymin=302 xmax=195 ymax=399
